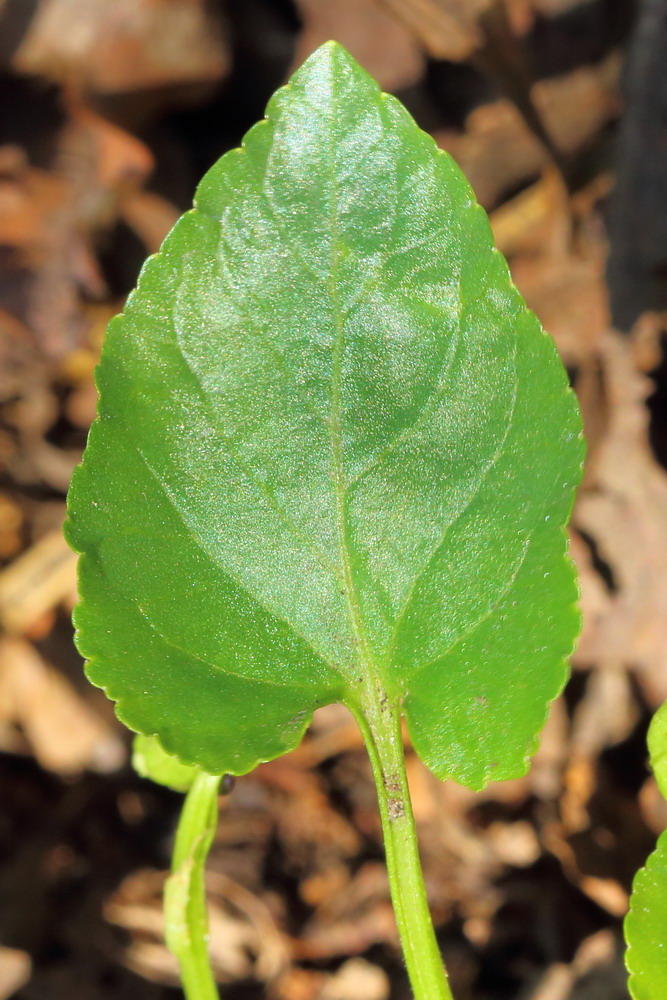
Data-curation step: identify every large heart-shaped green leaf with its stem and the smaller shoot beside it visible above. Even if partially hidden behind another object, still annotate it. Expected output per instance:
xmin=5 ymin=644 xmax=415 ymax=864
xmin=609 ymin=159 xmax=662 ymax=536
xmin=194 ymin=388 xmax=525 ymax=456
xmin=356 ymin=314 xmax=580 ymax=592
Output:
xmin=66 ymin=43 xmax=583 ymax=1000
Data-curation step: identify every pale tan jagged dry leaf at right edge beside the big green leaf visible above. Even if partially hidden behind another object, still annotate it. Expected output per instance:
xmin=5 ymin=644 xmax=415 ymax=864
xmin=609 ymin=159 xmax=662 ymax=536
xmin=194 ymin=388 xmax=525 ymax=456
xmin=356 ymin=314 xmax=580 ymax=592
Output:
xmin=574 ymin=331 xmax=667 ymax=708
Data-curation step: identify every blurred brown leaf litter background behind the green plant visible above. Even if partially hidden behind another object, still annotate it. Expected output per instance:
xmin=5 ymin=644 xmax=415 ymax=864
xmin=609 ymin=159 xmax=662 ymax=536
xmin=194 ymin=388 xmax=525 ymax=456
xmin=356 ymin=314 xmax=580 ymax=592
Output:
xmin=0 ymin=0 xmax=667 ymax=1000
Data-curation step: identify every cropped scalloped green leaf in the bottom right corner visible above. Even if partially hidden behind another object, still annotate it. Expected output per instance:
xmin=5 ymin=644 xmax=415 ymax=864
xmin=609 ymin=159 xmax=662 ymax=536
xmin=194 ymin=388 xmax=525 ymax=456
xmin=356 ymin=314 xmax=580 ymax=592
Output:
xmin=624 ymin=831 xmax=667 ymax=1000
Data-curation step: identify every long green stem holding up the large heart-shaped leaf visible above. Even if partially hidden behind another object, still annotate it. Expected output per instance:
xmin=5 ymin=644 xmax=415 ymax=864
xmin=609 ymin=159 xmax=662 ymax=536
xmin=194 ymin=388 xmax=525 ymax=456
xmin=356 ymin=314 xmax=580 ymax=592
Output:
xmin=352 ymin=692 xmax=453 ymax=1000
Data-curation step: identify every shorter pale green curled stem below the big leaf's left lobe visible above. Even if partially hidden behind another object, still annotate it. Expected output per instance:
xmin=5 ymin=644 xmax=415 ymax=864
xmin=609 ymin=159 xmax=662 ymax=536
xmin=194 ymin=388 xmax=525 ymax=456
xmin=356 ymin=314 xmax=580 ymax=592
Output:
xmin=164 ymin=772 xmax=222 ymax=1000
